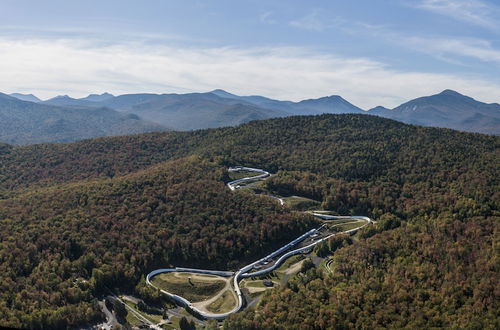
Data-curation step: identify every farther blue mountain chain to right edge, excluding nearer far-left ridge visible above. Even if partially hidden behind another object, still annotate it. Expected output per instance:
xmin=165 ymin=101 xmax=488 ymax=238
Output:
xmin=5 ymin=89 xmax=500 ymax=140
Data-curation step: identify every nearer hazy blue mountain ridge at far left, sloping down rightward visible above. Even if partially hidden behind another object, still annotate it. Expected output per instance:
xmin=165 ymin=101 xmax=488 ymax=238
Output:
xmin=0 ymin=93 xmax=166 ymax=144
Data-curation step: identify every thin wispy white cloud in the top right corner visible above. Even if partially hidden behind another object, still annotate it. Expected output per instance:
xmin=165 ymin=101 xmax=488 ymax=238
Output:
xmin=415 ymin=0 xmax=500 ymax=32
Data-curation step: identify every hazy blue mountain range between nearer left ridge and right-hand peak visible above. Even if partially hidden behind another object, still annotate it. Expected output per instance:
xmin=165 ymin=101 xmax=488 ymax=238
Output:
xmin=38 ymin=89 xmax=364 ymax=130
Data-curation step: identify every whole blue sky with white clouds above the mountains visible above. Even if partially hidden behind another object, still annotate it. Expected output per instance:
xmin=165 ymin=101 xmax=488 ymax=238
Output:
xmin=0 ymin=0 xmax=500 ymax=109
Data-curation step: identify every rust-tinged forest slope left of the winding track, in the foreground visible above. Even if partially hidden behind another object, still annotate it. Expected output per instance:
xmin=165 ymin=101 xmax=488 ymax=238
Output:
xmin=0 ymin=158 xmax=314 ymax=327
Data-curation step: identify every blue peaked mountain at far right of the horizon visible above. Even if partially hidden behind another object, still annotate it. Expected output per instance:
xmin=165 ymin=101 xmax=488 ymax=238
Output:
xmin=368 ymin=90 xmax=500 ymax=135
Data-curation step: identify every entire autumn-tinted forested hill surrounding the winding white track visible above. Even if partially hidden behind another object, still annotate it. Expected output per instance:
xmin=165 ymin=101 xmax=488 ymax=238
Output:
xmin=0 ymin=115 xmax=500 ymax=329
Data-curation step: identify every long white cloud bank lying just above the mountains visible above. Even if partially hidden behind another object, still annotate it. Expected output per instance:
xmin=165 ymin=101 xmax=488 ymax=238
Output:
xmin=0 ymin=38 xmax=500 ymax=108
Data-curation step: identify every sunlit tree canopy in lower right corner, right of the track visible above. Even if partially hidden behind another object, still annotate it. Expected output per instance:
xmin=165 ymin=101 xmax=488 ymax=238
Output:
xmin=225 ymin=217 xmax=500 ymax=329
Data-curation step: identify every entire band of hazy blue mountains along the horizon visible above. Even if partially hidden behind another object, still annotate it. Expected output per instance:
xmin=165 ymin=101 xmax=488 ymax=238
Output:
xmin=4 ymin=89 xmax=500 ymax=144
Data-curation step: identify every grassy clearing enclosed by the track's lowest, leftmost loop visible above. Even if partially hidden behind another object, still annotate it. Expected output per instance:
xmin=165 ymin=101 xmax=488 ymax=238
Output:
xmin=151 ymin=272 xmax=227 ymax=303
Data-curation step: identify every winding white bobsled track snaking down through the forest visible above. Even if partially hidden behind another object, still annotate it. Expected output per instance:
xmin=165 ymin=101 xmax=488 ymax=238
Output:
xmin=146 ymin=166 xmax=373 ymax=320
